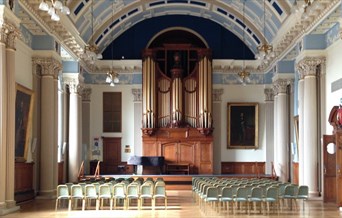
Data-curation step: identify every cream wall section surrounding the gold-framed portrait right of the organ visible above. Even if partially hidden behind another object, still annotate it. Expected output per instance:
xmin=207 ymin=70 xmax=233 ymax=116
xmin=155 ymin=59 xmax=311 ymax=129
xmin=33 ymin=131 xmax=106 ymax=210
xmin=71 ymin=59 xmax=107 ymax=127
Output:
xmin=214 ymin=85 xmax=266 ymax=162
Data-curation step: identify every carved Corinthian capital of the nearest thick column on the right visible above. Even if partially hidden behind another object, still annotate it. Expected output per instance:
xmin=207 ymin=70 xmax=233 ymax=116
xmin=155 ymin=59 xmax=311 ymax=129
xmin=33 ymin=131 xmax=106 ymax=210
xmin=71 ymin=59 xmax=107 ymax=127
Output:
xmin=296 ymin=57 xmax=325 ymax=78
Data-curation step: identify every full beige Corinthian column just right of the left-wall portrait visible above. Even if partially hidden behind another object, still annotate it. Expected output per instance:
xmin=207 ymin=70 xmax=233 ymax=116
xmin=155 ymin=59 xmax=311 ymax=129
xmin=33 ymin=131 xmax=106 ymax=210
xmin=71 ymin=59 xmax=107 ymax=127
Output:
xmin=33 ymin=58 xmax=61 ymax=198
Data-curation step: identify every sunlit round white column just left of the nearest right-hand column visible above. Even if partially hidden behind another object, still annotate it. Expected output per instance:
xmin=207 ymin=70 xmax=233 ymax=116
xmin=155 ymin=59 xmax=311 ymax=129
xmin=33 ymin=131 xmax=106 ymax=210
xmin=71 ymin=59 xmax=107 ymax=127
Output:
xmin=274 ymin=79 xmax=289 ymax=182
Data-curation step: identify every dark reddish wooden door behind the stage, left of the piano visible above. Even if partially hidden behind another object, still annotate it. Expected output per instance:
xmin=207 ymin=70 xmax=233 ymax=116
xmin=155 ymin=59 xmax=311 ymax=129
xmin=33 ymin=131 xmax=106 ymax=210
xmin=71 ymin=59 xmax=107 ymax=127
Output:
xmin=101 ymin=137 xmax=121 ymax=174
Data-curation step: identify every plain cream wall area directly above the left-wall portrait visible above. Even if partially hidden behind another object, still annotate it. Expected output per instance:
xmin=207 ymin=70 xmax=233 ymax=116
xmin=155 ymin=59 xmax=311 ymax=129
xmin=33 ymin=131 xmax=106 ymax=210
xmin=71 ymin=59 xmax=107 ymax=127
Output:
xmin=15 ymin=40 xmax=33 ymax=89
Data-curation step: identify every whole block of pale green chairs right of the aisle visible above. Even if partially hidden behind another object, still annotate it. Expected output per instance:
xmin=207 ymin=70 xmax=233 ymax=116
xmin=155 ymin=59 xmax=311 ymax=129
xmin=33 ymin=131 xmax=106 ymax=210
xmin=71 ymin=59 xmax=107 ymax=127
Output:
xmin=193 ymin=178 xmax=308 ymax=214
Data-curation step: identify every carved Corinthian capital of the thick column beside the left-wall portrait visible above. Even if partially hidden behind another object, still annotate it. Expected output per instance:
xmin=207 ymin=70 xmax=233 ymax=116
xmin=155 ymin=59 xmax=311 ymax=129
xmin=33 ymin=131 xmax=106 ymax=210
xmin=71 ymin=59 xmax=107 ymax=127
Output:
xmin=32 ymin=57 xmax=62 ymax=79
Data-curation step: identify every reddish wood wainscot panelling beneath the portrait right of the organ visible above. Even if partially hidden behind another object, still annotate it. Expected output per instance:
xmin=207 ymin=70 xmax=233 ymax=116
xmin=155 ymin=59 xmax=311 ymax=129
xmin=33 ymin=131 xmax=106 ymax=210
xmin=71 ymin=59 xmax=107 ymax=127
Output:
xmin=221 ymin=162 xmax=265 ymax=175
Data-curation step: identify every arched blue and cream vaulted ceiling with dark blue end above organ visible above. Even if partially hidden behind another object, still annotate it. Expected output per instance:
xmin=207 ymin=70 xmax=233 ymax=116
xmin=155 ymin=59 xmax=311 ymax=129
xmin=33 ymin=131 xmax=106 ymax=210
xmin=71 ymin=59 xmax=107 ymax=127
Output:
xmin=68 ymin=0 xmax=294 ymax=59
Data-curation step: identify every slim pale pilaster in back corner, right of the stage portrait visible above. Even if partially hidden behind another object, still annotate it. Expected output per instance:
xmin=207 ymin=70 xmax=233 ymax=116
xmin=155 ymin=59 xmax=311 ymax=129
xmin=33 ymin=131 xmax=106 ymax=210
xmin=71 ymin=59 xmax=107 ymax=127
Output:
xmin=264 ymin=88 xmax=274 ymax=174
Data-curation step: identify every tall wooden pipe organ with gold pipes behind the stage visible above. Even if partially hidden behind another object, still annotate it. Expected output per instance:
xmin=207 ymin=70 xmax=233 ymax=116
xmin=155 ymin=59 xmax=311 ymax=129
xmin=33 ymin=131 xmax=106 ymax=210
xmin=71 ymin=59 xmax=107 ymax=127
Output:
xmin=142 ymin=44 xmax=213 ymax=174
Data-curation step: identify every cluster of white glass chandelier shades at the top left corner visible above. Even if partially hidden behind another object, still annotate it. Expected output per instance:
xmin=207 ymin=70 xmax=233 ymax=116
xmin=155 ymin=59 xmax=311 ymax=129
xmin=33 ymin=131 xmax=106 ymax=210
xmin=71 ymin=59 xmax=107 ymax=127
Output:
xmin=39 ymin=0 xmax=70 ymax=21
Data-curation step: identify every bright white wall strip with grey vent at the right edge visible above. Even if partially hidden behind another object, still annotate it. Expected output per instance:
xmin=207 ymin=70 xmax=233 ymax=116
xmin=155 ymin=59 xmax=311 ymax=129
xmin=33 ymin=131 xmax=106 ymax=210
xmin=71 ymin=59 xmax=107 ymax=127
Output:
xmin=322 ymin=40 xmax=342 ymax=134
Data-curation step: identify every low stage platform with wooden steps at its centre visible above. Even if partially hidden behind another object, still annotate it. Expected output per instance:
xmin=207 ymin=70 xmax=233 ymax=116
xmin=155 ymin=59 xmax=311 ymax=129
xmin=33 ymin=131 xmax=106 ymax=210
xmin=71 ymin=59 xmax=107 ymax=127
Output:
xmin=85 ymin=174 xmax=274 ymax=190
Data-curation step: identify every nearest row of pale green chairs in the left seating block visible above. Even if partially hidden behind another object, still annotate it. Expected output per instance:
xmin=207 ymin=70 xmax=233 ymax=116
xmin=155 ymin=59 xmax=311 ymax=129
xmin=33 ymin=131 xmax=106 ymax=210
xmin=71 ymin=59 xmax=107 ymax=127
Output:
xmin=55 ymin=181 xmax=167 ymax=210
